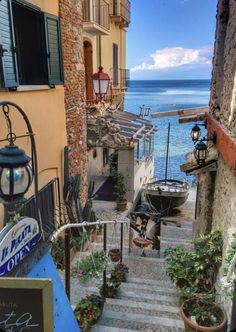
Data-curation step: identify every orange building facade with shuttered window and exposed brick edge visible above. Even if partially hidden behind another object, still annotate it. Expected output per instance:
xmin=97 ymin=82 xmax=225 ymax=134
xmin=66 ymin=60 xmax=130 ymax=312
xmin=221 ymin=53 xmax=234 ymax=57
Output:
xmin=0 ymin=0 xmax=87 ymax=226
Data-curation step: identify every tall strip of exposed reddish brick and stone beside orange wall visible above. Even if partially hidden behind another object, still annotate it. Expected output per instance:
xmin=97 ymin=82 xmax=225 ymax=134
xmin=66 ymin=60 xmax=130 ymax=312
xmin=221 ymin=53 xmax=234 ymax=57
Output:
xmin=59 ymin=0 xmax=88 ymax=202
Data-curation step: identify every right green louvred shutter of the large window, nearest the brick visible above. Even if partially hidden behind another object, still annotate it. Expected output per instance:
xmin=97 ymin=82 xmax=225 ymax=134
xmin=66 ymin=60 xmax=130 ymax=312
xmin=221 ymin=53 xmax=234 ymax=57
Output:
xmin=45 ymin=14 xmax=64 ymax=85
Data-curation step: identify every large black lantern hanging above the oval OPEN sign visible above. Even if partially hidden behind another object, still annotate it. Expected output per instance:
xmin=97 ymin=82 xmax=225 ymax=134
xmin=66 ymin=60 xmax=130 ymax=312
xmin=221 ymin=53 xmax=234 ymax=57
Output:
xmin=0 ymin=144 xmax=33 ymax=203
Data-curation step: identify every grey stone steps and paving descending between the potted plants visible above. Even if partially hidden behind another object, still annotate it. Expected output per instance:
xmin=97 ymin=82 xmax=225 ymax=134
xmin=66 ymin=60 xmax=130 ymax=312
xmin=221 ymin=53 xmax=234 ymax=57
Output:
xmin=71 ymin=190 xmax=195 ymax=332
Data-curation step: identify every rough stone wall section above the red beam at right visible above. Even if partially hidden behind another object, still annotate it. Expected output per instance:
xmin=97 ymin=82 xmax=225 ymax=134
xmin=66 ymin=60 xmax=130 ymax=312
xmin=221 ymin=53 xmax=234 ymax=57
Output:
xmin=210 ymin=0 xmax=236 ymax=137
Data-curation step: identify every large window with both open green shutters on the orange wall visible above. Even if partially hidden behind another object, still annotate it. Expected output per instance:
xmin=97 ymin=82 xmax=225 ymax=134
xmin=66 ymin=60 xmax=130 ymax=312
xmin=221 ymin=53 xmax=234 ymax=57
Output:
xmin=0 ymin=0 xmax=63 ymax=88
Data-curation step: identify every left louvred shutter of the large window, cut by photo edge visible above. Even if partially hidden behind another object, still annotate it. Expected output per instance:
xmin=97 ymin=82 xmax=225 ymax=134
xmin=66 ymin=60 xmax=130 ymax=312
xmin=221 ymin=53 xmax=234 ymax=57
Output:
xmin=0 ymin=0 xmax=19 ymax=88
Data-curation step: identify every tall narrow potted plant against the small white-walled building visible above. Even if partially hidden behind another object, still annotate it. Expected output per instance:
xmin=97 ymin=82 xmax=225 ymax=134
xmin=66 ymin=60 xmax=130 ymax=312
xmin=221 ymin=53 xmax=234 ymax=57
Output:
xmin=113 ymin=171 xmax=127 ymax=211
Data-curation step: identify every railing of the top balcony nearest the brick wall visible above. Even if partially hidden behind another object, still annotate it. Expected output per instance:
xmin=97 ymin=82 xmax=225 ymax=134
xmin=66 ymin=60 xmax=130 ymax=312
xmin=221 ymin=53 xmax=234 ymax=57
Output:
xmin=82 ymin=0 xmax=110 ymax=30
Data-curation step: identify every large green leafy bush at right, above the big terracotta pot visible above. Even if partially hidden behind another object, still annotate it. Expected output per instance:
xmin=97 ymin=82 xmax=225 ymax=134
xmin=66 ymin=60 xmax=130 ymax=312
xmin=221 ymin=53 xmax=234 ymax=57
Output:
xmin=164 ymin=231 xmax=223 ymax=296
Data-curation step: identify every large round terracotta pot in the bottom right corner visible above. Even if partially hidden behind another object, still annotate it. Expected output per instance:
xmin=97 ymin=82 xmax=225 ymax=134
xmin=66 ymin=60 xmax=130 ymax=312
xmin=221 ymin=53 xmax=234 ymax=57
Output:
xmin=180 ymin=300 xmax=227 ymax=332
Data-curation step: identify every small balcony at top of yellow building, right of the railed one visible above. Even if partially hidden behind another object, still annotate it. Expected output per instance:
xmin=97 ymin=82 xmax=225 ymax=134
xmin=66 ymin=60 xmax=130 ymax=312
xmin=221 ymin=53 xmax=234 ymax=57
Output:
xmin=110 ymin=0 xmax=130 ymax=28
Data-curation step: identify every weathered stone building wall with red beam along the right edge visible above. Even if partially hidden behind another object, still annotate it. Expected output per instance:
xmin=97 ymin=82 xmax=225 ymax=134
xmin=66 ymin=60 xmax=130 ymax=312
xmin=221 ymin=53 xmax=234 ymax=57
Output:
xmin=194 ymin=0 xmax=236 ymax=330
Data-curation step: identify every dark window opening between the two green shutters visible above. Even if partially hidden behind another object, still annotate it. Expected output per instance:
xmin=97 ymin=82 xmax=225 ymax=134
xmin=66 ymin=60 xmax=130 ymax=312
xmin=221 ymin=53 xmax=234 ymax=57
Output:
xmin=12 ymin=2 xmax=48 ymax=85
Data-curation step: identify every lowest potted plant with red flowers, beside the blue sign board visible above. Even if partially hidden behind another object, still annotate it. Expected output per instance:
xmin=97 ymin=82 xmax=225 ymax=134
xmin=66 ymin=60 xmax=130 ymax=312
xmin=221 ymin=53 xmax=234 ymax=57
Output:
xmin=74 ymin=295 xmax=104 ymax=332
